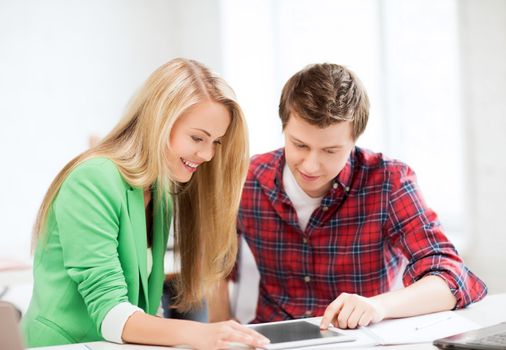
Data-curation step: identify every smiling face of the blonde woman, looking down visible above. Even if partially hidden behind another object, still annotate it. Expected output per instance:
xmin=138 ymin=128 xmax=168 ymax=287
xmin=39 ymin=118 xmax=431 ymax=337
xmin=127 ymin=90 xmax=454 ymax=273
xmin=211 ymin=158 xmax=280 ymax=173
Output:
xmin=167 ymin=101 xmax=231 ymax=183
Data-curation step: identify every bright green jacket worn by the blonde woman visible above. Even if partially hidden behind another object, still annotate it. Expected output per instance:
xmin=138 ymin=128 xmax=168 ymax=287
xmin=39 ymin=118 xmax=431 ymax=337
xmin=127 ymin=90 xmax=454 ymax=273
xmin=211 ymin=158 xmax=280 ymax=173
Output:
xmin=22 ymin=158 xmax=172 ymax=347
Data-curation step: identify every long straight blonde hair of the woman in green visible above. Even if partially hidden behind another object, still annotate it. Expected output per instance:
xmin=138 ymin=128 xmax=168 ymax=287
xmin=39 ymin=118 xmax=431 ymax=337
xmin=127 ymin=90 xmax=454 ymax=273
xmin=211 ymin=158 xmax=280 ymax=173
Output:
xmin=33 ymin=58 xmax=249 ymax=311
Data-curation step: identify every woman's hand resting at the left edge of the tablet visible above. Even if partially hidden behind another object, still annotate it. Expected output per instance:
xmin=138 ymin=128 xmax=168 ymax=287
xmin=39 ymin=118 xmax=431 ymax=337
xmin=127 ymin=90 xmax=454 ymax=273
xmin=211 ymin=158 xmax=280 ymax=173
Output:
xmin=188 ymin=320 xmax=270 ymax=350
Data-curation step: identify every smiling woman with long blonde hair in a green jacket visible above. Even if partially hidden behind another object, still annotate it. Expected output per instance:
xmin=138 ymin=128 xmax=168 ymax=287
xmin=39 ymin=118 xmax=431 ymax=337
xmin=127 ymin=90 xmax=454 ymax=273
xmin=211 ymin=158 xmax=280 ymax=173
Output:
xmin=23 ymin=59 xmax=267 ymax=349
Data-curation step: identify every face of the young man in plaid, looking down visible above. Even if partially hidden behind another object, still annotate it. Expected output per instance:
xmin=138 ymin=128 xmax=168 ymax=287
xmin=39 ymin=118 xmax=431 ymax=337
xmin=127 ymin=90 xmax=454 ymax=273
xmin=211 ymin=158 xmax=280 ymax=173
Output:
xmin=284 ymin=113 xmax=355 ymax=198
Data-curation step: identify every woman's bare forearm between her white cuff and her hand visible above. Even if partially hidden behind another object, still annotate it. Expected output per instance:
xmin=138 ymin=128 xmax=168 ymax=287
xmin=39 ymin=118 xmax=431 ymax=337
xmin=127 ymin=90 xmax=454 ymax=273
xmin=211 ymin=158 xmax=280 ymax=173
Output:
xmin=122 ymin=312 xmax=200 ymax=346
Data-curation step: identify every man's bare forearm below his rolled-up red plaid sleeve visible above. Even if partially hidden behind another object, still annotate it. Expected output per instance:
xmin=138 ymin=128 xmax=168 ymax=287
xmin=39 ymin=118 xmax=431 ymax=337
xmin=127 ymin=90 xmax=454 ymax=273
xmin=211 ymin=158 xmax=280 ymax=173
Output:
xmin=371 ymin=275 xmax=457 ymax=318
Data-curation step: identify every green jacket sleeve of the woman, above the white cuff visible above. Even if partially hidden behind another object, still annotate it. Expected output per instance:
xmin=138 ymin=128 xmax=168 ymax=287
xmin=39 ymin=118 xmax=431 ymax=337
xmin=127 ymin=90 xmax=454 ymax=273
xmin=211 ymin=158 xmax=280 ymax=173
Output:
xmin=53 ymin=161 xmax=132 ymax=333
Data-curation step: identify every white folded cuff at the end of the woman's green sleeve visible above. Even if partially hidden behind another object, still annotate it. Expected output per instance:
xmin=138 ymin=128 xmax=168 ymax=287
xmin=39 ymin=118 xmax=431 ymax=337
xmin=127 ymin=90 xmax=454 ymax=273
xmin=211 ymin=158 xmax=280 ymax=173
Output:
xmin=102 ymin=302 xmax=144 ymax=344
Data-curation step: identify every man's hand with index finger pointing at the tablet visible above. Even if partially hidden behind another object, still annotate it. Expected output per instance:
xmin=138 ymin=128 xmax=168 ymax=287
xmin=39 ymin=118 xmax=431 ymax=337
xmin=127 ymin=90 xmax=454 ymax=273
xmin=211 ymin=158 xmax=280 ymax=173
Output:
xmin=320 ymin=293 xmax=385 ymax=329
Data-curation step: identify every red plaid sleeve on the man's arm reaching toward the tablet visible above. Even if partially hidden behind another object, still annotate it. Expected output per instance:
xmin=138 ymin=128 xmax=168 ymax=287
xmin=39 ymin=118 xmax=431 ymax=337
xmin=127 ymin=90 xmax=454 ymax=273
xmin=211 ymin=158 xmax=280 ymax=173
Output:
xmin=387 ymin=166 xmax=487 ymax=308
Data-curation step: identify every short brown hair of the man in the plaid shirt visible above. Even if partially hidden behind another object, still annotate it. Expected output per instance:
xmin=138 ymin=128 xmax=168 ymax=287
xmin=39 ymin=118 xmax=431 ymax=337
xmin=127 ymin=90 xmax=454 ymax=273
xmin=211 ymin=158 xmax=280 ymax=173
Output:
xmin=279 ymin=63 xmax=369 ymax=140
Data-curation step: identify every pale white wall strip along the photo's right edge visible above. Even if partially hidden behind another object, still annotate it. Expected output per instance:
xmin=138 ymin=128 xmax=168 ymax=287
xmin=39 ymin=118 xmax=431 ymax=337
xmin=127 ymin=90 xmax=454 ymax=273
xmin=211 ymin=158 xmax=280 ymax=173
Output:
xmin=459 ymin=0 xmax=506 ymax=293
